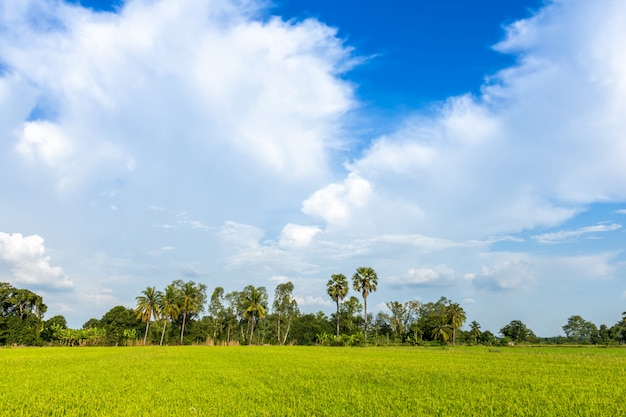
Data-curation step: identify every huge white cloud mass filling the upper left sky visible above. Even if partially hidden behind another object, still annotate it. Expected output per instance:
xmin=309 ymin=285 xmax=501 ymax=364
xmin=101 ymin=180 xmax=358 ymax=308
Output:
xmin=0 ymin=0 xmax=356 ymax=193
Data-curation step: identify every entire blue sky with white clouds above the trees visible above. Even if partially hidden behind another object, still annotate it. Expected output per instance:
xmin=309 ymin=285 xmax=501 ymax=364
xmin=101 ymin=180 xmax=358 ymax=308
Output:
xmin=0 ymin=0 xmax=626 ymax=337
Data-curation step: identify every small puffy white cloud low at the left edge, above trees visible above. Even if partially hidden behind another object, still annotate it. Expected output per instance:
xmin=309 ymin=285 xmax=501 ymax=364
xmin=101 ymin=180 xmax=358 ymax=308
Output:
xmin=0 ymin=232 xmax=73 ymax=289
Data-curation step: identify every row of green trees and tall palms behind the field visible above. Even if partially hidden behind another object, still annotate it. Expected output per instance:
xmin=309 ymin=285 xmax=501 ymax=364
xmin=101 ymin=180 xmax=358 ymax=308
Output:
xmin=0 ymin=267 xmax=626 ymax=346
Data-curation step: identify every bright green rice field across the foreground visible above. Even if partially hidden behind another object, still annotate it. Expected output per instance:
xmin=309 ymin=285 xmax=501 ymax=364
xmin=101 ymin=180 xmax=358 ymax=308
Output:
xmin=0 ymin=346 xmax=626 ymax=417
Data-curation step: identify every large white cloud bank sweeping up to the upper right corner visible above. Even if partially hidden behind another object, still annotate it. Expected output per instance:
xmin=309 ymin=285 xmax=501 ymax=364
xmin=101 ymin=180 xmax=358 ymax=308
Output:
xmin=303 ymin=1 xmax=626 ymax=239
